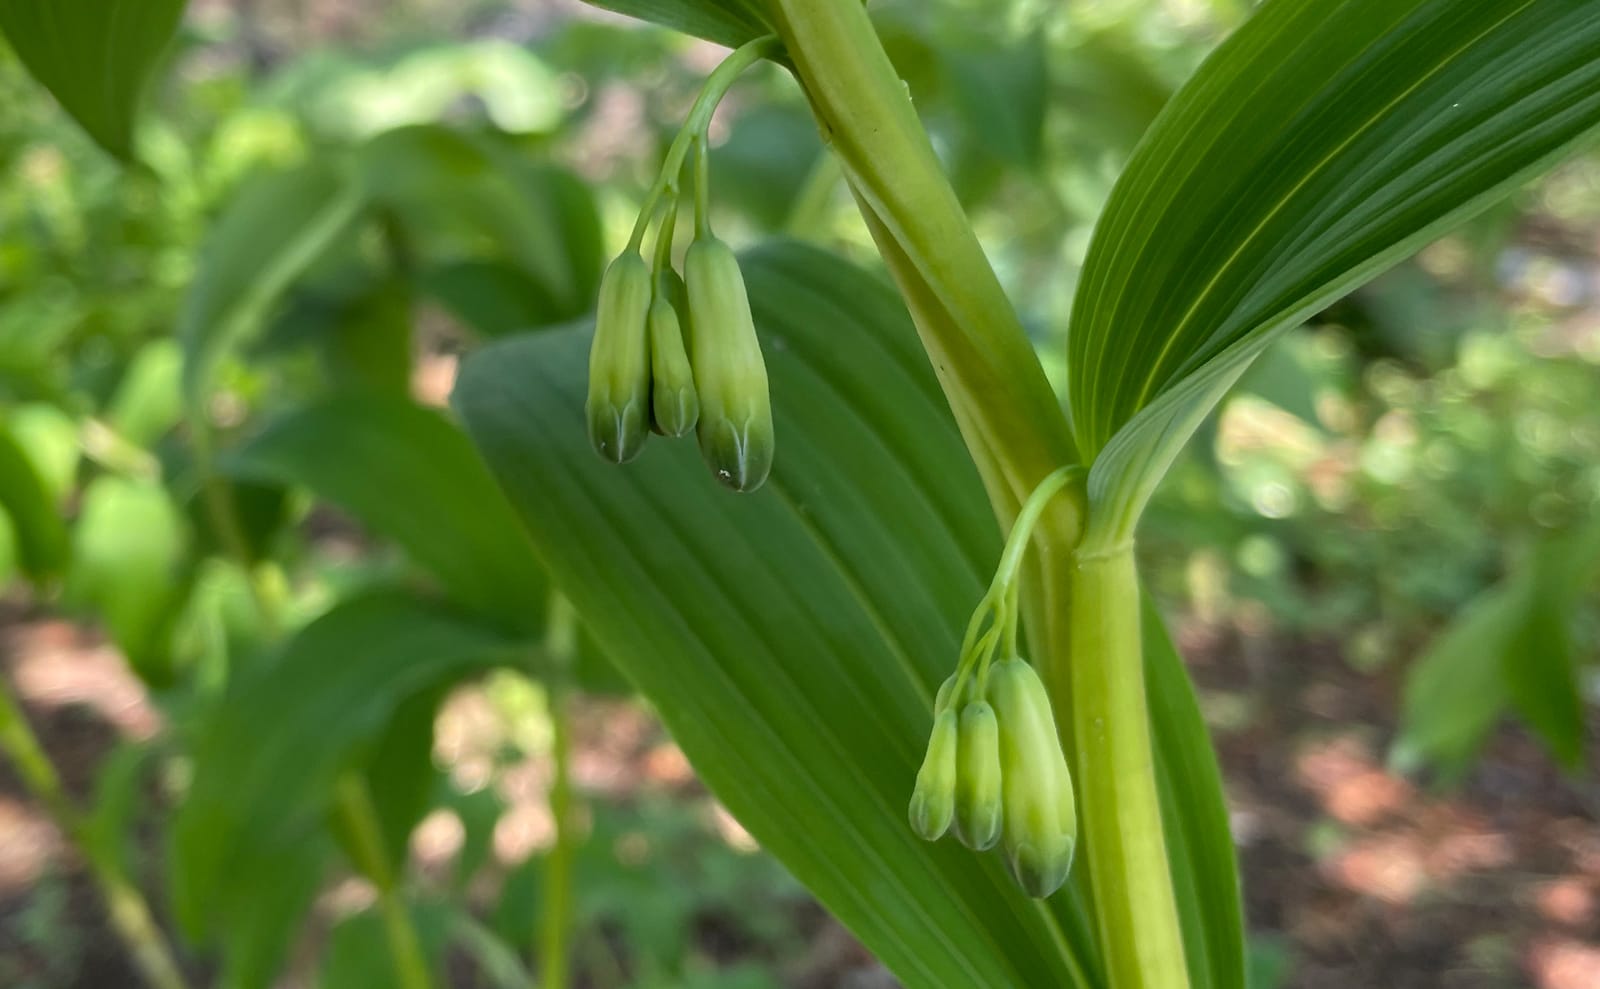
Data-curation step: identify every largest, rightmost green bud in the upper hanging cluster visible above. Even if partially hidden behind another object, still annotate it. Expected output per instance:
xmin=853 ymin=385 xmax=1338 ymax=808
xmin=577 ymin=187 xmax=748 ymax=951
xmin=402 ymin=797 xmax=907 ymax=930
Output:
xmin=683 ymin=235 xmax=774 ymax=491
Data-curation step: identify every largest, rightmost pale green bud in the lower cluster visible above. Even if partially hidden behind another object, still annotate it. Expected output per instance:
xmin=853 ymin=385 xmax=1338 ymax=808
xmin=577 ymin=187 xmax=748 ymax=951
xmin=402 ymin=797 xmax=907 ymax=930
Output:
xmin=989 ymin=659 xmax=1078 ymax=898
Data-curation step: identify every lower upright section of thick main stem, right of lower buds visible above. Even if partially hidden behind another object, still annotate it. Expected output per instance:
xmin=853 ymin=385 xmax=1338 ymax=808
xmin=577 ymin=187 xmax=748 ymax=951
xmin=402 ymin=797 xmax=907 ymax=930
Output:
xmin=1058 ymin=543 xmax=1189 ymax=989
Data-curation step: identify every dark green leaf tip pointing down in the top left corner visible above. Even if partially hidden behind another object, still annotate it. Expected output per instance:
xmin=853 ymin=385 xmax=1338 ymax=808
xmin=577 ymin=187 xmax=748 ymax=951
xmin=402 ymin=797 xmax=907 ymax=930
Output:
xmin=0 ymin=0 xmax=184 ymax=160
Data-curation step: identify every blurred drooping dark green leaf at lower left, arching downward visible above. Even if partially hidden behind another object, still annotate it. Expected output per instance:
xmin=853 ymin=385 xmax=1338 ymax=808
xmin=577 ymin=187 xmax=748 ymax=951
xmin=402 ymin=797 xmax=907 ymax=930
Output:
xmin=170 ymin=592 xmax=515 ymax=986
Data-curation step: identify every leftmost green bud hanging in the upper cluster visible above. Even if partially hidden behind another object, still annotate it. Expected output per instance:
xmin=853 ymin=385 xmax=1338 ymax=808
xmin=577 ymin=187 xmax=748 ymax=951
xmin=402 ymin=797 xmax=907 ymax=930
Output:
xmin=584 ymin=251 xmax=650 ymax=464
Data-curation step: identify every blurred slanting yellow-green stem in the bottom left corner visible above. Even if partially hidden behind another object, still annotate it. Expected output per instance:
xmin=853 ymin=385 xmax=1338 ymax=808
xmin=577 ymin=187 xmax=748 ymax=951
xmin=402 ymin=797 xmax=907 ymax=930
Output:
xmin=0 ymin=680 xmax=187 ymax=989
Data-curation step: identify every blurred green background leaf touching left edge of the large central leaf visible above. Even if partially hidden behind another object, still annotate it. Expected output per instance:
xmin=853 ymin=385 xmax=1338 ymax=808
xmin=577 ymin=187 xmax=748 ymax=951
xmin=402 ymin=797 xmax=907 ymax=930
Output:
xmin=222 ymin=395 xmax=549 ymax=631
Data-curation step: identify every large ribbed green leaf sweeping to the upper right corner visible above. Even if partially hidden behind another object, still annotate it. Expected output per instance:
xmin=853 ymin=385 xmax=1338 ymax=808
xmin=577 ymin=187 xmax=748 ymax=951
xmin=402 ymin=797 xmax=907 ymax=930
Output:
xmin=1069 ymin=0 xmax=1600 ymax=539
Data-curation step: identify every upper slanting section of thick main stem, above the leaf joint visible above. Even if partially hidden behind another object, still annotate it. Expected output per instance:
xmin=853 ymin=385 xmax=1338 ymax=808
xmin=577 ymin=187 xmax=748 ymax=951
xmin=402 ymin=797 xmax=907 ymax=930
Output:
xmin=770 ymin=0 xmax=1077 ymax=527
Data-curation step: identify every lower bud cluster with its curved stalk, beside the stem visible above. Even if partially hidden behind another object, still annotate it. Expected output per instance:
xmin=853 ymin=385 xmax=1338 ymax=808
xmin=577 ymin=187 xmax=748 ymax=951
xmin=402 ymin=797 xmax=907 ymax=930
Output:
xmin=909 ymin=469 xmax=1082 ymax=898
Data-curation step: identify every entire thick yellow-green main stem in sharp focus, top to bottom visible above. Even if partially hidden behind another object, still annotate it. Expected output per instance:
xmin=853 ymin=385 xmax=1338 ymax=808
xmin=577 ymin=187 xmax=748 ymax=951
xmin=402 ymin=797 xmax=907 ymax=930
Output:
xmin=770 ymin=7 xmax=1187 ymax=989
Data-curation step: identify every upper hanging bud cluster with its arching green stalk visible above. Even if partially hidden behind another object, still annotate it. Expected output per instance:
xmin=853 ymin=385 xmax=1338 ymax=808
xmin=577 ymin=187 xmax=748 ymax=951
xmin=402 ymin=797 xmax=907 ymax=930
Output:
xmin=586 ymin=38 xmax=776 ymax=491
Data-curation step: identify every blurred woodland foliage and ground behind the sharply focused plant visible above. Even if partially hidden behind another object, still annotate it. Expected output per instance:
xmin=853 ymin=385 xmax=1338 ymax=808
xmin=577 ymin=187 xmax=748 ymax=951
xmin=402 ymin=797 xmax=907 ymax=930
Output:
xmin=0 ymin=0 xmax=1600 ymax=989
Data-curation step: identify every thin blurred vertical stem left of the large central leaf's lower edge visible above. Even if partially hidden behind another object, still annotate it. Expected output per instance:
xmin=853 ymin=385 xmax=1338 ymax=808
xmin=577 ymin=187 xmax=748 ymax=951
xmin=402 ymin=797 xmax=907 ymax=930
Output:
xmin=539 ymin=592 xmax=578 ymax=989
